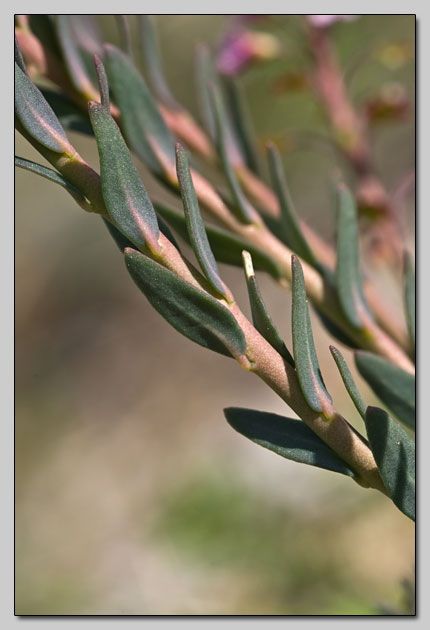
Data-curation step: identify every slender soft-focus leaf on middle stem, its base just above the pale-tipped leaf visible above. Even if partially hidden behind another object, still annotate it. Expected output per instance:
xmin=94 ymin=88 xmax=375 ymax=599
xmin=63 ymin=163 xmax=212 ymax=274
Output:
xmin=209 ymin=84 xmax=255 ymax=223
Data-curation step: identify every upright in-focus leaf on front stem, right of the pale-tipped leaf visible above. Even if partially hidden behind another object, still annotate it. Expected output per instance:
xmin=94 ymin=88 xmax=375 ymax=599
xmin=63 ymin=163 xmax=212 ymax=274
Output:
xmin=291 ymin=255 xmax=333 ymax=418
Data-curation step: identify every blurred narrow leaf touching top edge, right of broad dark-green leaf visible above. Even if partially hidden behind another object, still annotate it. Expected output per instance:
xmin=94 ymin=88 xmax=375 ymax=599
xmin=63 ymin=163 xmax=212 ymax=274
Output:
xmin=138 ymin=15 xmax=182 ymax=111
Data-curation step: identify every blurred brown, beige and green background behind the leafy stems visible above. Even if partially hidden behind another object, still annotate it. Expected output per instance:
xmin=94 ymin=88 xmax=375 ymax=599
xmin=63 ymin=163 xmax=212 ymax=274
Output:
xmin=15 ymin=15 xmax=415 ymax=615
